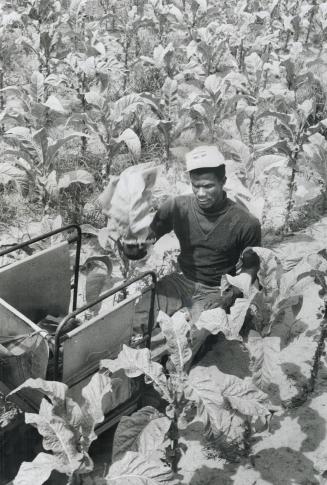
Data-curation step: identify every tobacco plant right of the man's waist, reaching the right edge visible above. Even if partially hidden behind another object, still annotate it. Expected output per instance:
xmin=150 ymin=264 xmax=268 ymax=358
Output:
xmin=227 ymin=247 xmax=327 ymax=398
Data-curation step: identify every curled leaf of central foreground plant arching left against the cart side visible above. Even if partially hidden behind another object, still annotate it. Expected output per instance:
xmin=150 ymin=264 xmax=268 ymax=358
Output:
xmin=100 ymin=345 xmax=171 ymax=402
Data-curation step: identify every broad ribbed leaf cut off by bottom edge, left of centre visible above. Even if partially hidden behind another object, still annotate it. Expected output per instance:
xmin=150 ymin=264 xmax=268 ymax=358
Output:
xmin=105 ymin=451 xmax=173 ymax=485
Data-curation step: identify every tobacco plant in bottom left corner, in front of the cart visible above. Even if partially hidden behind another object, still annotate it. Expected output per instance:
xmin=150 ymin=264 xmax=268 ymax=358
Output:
xmin=10 ymin=373 xmax=115 ymax=485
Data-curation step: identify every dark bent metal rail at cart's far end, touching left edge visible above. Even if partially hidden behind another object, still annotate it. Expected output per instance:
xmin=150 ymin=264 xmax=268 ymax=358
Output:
xmin=0 ymin=224 xmax=82 ymax=310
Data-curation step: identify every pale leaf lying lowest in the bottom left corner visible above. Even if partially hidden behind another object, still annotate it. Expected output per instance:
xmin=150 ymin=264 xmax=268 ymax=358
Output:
xmin=12 ymin=453 xmax=65 ymax=485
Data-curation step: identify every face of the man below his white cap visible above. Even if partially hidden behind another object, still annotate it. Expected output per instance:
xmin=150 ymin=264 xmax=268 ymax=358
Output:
xmin=190 ymin=172 xmax=225 ymax=209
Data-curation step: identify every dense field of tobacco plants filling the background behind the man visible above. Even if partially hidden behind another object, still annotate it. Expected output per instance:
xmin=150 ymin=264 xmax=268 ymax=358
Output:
xmin=0 ymin=0 xmax=327 ymax=231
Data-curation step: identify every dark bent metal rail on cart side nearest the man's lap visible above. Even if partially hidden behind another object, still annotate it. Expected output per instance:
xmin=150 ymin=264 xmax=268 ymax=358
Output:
xmin=54 ymin=271 xmax=157 ymax=381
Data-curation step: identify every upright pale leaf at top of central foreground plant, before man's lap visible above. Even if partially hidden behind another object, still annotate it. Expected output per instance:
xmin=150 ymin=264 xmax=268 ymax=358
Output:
xmin=157 ymin=311 xmax=192 ymax=373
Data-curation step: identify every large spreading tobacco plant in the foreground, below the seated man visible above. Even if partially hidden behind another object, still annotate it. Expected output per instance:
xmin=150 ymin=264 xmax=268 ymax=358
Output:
xmin=101 ymin=303 xmax=270 ymax=472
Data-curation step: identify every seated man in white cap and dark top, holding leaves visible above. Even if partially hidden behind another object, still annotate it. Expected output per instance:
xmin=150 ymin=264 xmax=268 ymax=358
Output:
xmin=131 ymin=146 xmax=261 ymax=328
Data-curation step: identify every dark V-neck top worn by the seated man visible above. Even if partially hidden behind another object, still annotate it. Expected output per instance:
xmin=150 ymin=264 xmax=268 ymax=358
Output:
xmin=151 ymin=194 xmax=261 ymax=286
